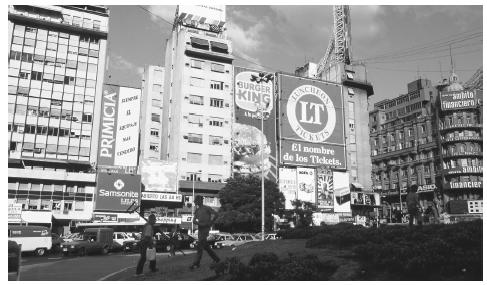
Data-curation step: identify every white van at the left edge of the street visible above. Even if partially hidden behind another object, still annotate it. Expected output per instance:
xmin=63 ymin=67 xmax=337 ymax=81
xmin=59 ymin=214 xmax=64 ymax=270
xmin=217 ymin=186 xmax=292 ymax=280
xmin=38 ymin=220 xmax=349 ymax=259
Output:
xmin=8 ymin=225 xmax=52 ymax=256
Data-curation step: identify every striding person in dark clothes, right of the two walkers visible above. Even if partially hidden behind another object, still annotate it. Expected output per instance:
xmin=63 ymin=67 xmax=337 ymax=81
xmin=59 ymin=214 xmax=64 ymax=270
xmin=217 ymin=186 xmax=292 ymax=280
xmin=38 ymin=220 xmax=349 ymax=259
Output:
xmin=190 ymin=195 xmax=220 ymax=269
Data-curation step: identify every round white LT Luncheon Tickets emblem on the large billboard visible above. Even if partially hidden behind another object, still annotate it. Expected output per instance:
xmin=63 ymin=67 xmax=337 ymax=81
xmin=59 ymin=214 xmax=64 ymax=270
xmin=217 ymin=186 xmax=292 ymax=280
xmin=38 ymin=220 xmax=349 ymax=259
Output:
xmin=287 ymin=85 xmax=336 ymax=143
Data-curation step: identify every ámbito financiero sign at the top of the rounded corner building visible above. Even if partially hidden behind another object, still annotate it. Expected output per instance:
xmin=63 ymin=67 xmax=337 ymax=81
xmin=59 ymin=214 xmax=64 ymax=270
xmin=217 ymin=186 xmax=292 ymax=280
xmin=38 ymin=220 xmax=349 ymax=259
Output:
xmin=440 ymin=90 xmax=483 ymax=111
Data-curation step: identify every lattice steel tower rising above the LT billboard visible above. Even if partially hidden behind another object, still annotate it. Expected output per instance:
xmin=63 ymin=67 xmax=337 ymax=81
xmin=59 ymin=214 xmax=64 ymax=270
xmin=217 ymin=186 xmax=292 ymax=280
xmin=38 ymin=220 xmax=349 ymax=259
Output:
xmin=316 ymin=5 xmax=352 ymax=78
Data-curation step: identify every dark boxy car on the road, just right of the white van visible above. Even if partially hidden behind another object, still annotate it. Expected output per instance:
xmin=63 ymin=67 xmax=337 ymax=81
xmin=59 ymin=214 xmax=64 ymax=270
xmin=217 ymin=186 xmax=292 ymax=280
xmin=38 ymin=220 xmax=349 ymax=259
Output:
xmin=61 ymin=228 xmax=113 ymax=256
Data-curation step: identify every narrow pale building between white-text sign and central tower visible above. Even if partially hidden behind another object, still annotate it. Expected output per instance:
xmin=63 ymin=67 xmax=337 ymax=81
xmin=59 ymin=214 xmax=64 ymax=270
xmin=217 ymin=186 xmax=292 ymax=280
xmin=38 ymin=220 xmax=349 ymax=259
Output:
xmin=139 ymin=65 xmax=164 ymax=161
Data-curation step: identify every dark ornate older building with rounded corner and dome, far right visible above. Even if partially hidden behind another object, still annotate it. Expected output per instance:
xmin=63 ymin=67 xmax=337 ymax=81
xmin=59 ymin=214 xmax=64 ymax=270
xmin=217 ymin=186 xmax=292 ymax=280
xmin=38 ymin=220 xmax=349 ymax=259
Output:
xmin=369 ymin=74 xmax=482 ymax=217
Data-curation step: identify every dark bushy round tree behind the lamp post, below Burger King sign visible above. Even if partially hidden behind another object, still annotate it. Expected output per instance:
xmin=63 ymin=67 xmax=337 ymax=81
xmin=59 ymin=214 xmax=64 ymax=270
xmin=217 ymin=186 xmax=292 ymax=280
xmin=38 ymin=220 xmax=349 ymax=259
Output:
xmin=215 ymin=175 xmax=284 ymax=232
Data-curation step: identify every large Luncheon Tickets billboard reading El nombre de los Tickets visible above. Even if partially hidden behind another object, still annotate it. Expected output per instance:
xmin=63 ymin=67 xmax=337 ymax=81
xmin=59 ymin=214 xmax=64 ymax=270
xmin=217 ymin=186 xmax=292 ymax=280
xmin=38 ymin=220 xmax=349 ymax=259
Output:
xmin=278 ymin=74 xmax=346 ymax=169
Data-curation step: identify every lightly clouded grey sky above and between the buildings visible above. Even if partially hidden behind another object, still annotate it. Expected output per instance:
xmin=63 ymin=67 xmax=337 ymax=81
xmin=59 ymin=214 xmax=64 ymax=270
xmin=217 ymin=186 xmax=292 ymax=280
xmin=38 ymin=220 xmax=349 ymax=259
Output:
xmin=107 ymin=5 xmax=483 ymax=109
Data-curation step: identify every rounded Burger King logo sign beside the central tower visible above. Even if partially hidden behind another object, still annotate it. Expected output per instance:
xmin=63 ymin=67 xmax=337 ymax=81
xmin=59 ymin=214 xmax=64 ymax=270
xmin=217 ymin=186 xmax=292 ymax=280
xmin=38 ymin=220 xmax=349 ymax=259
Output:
xmin=235 ymin=71 xmax=273 ymax=112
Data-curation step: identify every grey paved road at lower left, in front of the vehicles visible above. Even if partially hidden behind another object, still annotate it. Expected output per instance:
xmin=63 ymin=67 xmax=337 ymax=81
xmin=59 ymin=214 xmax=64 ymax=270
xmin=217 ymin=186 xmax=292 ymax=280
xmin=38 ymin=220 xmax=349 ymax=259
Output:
xmin=20 ymin=250 xmax=194 ymax=281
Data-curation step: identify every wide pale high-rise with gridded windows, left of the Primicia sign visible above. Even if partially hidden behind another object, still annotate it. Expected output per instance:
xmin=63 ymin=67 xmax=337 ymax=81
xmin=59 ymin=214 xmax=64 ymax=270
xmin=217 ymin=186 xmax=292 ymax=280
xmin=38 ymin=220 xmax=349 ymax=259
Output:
xmin=8 ymin=5 xmax=109 ymax=233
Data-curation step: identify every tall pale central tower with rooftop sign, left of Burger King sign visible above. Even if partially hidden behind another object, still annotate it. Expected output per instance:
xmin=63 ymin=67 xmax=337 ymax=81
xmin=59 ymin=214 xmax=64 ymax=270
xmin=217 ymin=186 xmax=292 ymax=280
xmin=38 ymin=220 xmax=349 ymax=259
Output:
xmin=162 ymin=6 xmax=233 ymax=207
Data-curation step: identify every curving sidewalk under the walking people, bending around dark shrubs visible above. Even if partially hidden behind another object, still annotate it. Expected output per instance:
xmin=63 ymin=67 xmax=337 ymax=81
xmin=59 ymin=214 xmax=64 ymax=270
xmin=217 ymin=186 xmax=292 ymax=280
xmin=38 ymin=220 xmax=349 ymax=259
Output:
xmin=105 ymin=240 xmax=360 ymax=281
